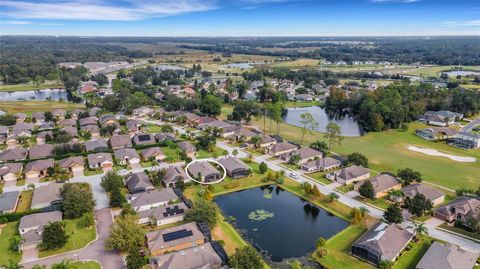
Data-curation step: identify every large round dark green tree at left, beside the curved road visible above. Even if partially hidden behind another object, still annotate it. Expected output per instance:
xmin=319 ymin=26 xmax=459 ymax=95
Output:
xmin=60 ymin=183 xmax=95 ymax=218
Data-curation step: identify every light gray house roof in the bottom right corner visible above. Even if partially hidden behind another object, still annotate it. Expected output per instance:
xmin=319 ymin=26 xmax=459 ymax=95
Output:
xmin=415 ymin=241 xmax=478 ymax=269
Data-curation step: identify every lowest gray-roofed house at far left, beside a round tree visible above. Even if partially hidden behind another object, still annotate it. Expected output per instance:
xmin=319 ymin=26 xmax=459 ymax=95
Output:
xmin=18 ymin=211 xmax=62 ymax=251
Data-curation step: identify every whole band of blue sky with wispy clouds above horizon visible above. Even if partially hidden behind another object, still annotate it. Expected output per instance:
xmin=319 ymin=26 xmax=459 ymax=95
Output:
xmin=0 ymin=0 xmax=480 ymax=36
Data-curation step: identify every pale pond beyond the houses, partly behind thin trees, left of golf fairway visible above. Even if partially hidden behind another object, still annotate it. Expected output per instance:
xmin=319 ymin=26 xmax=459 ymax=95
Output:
xmin=283 ymin=106 xmax=363 ymax=136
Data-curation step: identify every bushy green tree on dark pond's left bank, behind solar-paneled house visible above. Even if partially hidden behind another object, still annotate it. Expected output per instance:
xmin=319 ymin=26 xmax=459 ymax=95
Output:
xmin=185 ymin=199 xmax=218 ymax=229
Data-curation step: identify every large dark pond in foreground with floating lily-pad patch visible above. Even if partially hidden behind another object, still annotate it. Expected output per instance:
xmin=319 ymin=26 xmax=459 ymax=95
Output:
xmin=214 ymin=185 xmax=348 ymax=262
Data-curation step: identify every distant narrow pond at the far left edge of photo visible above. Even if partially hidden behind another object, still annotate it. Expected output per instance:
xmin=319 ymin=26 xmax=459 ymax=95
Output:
xmin=0 ymin=89 xmax=67 ymax=101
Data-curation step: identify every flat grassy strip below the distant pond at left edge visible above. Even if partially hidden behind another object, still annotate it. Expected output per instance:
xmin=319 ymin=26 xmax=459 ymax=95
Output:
xmin=0 ymin=101 xmax=85 ymax=114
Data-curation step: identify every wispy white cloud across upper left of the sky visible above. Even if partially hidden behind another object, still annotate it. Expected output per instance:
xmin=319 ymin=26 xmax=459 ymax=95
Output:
xmin=0 ymin=0 xmax=216 ymax=21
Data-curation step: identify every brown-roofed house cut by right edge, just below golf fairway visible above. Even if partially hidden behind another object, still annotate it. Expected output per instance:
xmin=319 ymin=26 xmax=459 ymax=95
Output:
xmin=434 ymin=196 xmax=480 ymax=223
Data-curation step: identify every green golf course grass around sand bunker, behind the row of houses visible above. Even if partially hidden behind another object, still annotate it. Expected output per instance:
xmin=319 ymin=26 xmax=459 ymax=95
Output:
xmin=251 ymin=116 xmax=480 ymax=189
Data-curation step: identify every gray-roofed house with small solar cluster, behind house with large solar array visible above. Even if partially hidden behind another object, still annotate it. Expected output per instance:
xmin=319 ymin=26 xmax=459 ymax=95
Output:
xmin=138 ymin=202 xmax=188 ymax=226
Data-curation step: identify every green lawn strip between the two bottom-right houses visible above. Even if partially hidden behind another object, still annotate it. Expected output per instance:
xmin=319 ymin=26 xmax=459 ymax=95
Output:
xmin=393 ymin=236 xmax=433 ymax=269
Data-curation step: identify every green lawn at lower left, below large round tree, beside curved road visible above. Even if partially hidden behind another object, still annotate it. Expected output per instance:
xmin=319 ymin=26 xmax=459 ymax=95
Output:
xmin=38 ymin=218 xmax=97 ymax=258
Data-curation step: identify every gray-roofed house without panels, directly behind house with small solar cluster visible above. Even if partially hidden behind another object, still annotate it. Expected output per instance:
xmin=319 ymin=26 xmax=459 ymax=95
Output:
xmin=127 ymin=188 xmax=178 ymax=212
